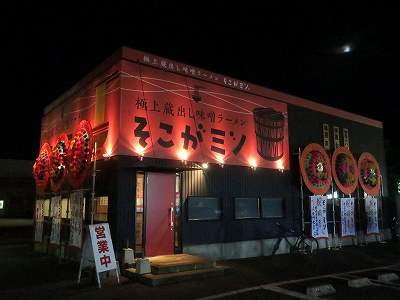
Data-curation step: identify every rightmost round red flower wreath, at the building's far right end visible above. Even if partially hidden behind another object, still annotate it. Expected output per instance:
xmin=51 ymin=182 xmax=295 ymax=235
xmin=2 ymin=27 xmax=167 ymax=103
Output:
xmin=358 ymin=152 xmax=381 ymax=196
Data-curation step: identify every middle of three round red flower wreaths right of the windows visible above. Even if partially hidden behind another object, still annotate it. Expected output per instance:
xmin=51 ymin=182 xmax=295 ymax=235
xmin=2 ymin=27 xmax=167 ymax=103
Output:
xmin=332 ymin=147 xmax=358 ymax=194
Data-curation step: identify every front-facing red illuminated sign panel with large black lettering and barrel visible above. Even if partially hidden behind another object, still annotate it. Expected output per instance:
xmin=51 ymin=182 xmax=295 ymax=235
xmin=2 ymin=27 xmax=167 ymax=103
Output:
xmin=120 ymin=64 xmax=289 ymax=169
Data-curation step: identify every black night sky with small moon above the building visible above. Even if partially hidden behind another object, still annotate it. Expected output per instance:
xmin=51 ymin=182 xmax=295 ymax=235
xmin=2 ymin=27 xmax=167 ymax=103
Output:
xmin=0 ymin=0 xmax=400 ymax=160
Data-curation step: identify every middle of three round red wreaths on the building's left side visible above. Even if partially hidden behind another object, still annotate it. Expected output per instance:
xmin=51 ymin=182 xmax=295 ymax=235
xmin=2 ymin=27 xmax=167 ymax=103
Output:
xmin=49 ymin=133 xmax=69 ymax=192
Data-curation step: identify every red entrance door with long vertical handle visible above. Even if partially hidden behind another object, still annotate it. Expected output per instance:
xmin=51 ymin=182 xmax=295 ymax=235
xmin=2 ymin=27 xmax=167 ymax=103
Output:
xmin=145 ymin=173 xmax=175 ymax=256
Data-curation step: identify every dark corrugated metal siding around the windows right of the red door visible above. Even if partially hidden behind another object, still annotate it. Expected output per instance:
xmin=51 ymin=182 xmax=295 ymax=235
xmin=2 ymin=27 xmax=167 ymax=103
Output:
xmin=182 ymin=165 xmax=296 ymax=245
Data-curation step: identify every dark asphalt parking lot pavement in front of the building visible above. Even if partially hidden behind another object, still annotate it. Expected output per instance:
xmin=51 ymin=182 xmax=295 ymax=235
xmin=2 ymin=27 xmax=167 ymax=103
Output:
xmin=0 ymin=222 xmax=400 ymax=300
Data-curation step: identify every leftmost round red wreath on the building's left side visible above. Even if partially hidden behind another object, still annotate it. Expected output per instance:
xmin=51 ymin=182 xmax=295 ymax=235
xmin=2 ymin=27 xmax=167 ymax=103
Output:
xmin=32 ymin=143 xmax=50 ymax=195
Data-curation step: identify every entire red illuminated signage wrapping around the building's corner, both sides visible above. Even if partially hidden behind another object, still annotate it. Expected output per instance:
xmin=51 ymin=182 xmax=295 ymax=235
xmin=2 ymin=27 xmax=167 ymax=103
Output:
xmin=42 ymin=50 xmax=290 ymax=170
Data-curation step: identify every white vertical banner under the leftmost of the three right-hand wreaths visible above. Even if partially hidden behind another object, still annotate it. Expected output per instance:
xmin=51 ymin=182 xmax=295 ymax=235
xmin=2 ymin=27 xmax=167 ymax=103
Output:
xmin=310 ymin=195 xmax=328 ymax=239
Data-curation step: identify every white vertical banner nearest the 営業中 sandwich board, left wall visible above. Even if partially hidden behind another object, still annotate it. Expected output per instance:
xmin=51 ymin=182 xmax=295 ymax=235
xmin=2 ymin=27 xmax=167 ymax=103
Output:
xmin=69 ymin=191 xmax=83 ymax=249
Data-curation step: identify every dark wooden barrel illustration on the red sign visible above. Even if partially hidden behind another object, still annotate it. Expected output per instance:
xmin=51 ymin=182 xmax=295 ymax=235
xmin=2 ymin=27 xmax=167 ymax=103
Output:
xmin=253 ymin=107 xmax=285 ymax=161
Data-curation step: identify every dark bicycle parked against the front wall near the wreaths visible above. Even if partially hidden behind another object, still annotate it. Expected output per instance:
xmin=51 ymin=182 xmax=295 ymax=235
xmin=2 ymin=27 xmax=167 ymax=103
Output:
xmin=272 ymin=222 xmax=319 ymax=257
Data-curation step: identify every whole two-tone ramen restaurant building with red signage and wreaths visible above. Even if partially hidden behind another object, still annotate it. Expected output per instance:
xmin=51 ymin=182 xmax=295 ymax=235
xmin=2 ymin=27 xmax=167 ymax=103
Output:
xmin=33 ymin=47 xmax=390 ymax=259
